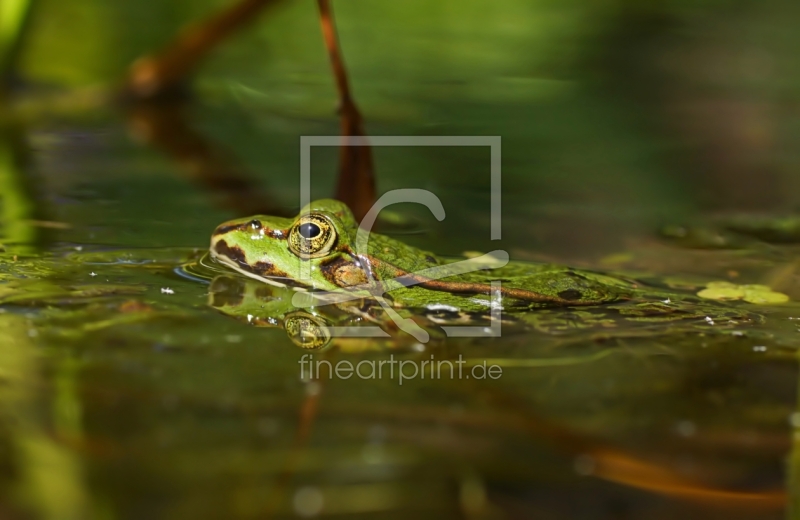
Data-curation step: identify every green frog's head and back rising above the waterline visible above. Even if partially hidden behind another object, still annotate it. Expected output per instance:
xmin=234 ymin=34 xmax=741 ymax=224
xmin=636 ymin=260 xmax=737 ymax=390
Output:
xmin=210 ymin=200 xmax=634 ymax=311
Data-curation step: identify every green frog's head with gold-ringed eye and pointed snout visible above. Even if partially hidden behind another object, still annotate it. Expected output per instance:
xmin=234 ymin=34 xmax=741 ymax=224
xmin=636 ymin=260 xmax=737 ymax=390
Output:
xmin=210 ymin=199 xmax=358 ymax=290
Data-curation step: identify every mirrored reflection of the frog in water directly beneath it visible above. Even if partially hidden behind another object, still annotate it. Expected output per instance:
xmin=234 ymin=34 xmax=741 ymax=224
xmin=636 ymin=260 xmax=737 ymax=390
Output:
xmin=203 ymin=268 xmax=761 ymax=351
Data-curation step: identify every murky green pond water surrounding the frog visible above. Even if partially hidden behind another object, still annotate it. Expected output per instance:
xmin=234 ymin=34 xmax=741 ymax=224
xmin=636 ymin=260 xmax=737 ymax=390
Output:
xmin=0 ymin=0 xmax=800 ymax=519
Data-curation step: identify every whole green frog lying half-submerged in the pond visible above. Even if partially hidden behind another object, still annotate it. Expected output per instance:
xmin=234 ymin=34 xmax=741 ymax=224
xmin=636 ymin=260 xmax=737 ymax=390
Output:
xmin=208 ymin=199 xmax=761 ymax=344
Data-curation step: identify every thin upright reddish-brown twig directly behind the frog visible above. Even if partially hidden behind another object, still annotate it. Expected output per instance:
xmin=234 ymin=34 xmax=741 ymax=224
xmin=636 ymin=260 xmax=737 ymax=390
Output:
xmin=317 ymin=0 xmax=376 ymax=220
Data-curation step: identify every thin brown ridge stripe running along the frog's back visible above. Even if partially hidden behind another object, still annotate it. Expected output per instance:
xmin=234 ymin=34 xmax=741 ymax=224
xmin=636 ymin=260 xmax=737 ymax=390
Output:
xmin=367 ymin=256 xmax=616 ymax=306
